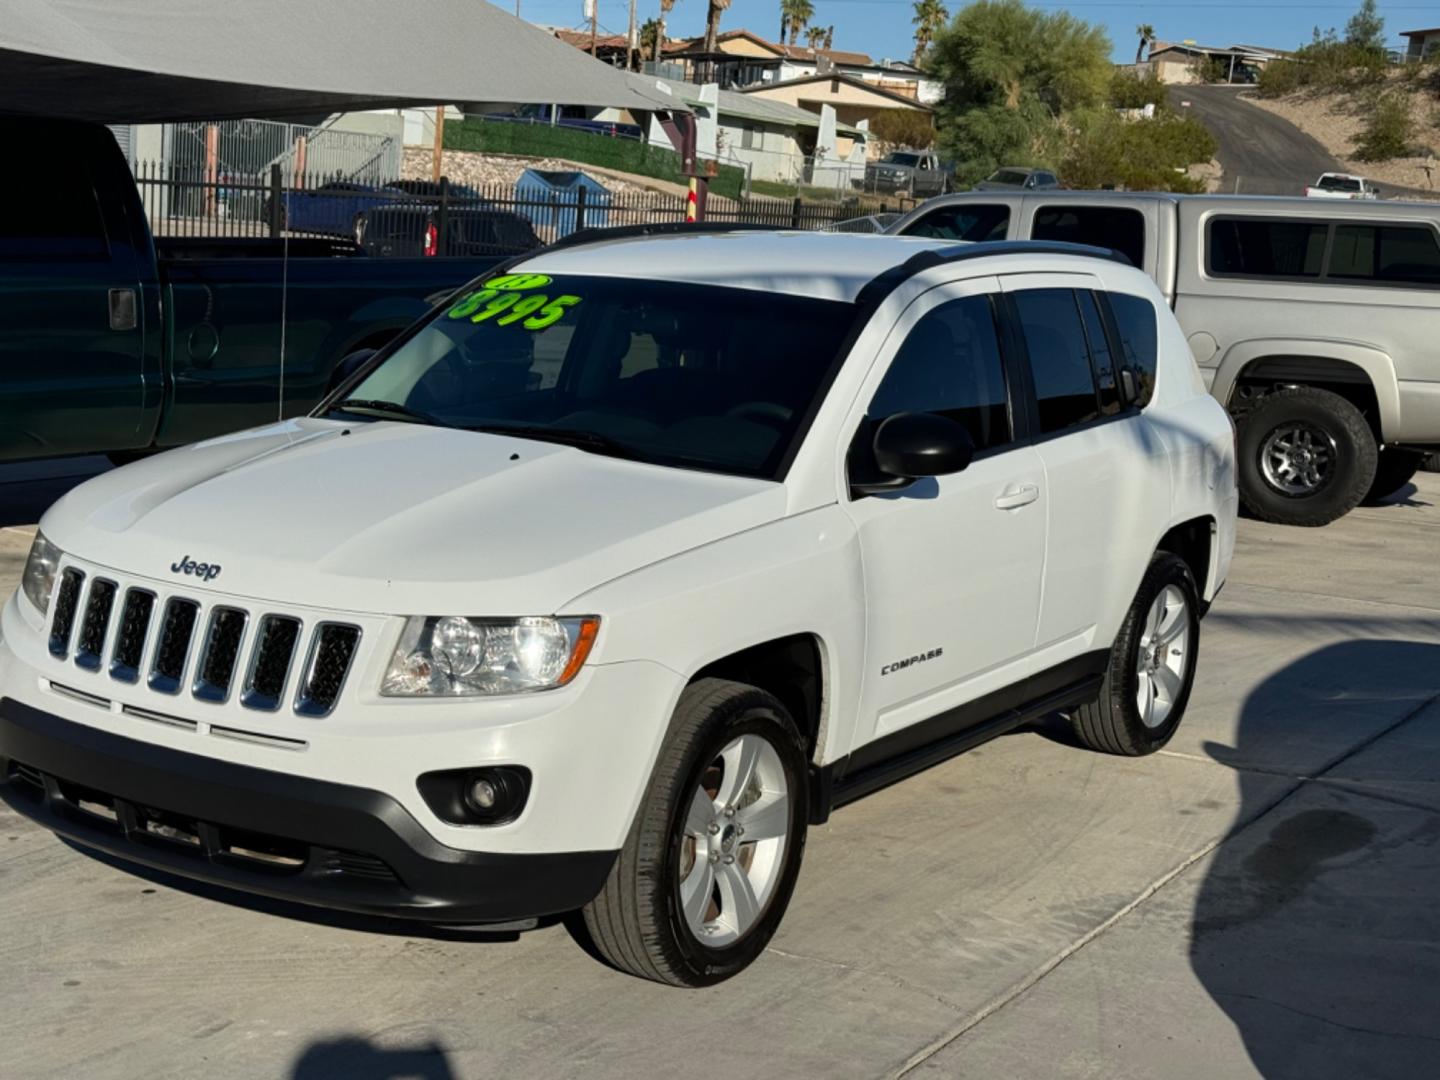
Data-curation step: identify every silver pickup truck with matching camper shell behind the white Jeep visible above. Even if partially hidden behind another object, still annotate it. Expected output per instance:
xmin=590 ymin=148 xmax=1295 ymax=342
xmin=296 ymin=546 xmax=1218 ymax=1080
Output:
xmin=886 ymin=192 xmax=1440 ymax=526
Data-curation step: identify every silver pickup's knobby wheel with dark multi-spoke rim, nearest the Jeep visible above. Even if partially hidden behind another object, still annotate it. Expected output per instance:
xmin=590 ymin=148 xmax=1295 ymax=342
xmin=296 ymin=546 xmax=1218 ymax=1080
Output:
xmin=1236 ymin=386 xmax=1378 ymax=526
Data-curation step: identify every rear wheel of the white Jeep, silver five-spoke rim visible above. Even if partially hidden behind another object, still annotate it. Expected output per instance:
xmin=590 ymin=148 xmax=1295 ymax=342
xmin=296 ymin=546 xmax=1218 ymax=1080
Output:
xmin=1070 ymin=552 xmax=1200 ymax=757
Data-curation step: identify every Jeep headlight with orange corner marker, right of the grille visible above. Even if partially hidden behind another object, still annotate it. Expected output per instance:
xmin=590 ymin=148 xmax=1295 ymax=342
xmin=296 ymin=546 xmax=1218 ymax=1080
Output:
xmin=380 ymin=615 xmax=600 ymax=697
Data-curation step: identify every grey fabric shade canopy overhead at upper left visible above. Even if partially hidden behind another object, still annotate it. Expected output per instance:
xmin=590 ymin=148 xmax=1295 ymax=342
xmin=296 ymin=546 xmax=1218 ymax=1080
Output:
xmin=0 ymin=0 xmax=688 ymax=124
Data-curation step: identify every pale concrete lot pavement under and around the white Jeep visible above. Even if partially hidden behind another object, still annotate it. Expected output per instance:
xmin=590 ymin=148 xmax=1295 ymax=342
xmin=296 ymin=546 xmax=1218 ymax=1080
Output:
xmin=0 ymin=474 xmax=1440 ymax=1080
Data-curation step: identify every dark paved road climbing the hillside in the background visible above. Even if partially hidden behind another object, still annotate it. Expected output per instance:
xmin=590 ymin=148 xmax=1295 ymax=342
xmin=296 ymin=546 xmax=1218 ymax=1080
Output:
xmin=1171 ymin=86 xmax=1345 ymax=194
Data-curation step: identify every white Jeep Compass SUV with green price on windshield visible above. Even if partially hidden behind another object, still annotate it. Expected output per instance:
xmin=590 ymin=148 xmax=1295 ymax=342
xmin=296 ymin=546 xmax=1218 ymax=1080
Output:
xmin=0 ymin=228 xmax=1237 ymax=985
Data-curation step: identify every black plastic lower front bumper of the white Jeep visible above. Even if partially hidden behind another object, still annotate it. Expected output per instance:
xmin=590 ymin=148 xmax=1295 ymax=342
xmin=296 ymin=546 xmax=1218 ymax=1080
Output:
xmin=0 ymin=698 xmax=618 ymax=923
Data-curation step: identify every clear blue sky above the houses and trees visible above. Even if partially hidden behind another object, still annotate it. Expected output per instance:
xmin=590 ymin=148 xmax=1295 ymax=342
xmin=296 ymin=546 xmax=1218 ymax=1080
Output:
xmin=500 ymin=0 xmax=1440 ymax=60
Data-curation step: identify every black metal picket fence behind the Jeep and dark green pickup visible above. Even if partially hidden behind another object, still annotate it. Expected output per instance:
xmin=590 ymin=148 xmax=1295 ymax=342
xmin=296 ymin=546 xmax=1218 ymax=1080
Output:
xmin=135 ymin=161 xmax=901 ymax=255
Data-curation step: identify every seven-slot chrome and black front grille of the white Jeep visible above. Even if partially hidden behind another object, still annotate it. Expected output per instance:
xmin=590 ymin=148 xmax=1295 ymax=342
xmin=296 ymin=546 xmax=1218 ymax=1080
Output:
xmin=49 ymin=567 xmax=360 ymax=720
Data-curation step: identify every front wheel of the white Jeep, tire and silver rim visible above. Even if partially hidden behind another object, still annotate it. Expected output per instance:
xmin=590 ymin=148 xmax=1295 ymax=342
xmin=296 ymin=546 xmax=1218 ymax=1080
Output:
xmin=583 ymin=678 xmax=809 ymax=986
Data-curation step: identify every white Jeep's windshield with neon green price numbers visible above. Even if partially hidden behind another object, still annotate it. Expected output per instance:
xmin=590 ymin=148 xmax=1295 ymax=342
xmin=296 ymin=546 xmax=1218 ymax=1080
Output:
xmin=331 ymin=274 xmax=854 ymax=477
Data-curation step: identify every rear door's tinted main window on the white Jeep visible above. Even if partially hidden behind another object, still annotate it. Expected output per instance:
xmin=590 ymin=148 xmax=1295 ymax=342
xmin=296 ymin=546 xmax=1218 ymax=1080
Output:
xmin=1014 ymin=289 xmax=1100 ymax=433
